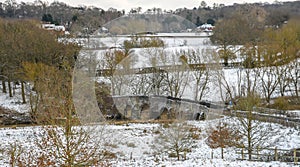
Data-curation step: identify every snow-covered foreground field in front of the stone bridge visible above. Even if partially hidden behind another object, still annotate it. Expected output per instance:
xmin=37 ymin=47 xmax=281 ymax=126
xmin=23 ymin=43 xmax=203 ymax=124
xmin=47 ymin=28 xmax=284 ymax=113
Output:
xmin=0 ymin=120 xmax=300 ymax=167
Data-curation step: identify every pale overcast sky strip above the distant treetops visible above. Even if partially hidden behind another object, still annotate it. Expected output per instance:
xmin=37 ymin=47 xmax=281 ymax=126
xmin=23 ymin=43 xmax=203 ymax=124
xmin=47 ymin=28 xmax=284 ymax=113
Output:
xmin=0 ymin=0 xmax=299 ymax=12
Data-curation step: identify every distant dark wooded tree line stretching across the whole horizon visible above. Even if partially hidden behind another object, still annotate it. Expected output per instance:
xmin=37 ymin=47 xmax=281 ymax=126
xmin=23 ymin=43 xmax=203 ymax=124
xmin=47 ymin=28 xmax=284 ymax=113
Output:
xmin=0 ymin=0 xmax=300 ymax=33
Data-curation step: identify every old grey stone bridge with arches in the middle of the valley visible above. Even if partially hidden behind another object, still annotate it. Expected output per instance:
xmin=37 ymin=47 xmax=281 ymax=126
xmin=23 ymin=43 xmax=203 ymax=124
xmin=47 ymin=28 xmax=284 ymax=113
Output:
xmin=113 ymin=96 xmax=209 ymax=120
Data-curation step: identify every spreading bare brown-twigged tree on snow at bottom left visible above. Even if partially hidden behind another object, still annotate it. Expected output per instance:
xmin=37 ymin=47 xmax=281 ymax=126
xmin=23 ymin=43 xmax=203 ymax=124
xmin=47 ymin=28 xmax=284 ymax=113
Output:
xmin=7 ymin=125 xmax=115 ymax=167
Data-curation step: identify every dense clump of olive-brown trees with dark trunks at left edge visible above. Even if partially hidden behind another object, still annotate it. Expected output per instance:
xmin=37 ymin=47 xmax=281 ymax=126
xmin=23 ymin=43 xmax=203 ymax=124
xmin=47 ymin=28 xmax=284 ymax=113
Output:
xmin=0 ymin=19 xmax=79 ymax=103
